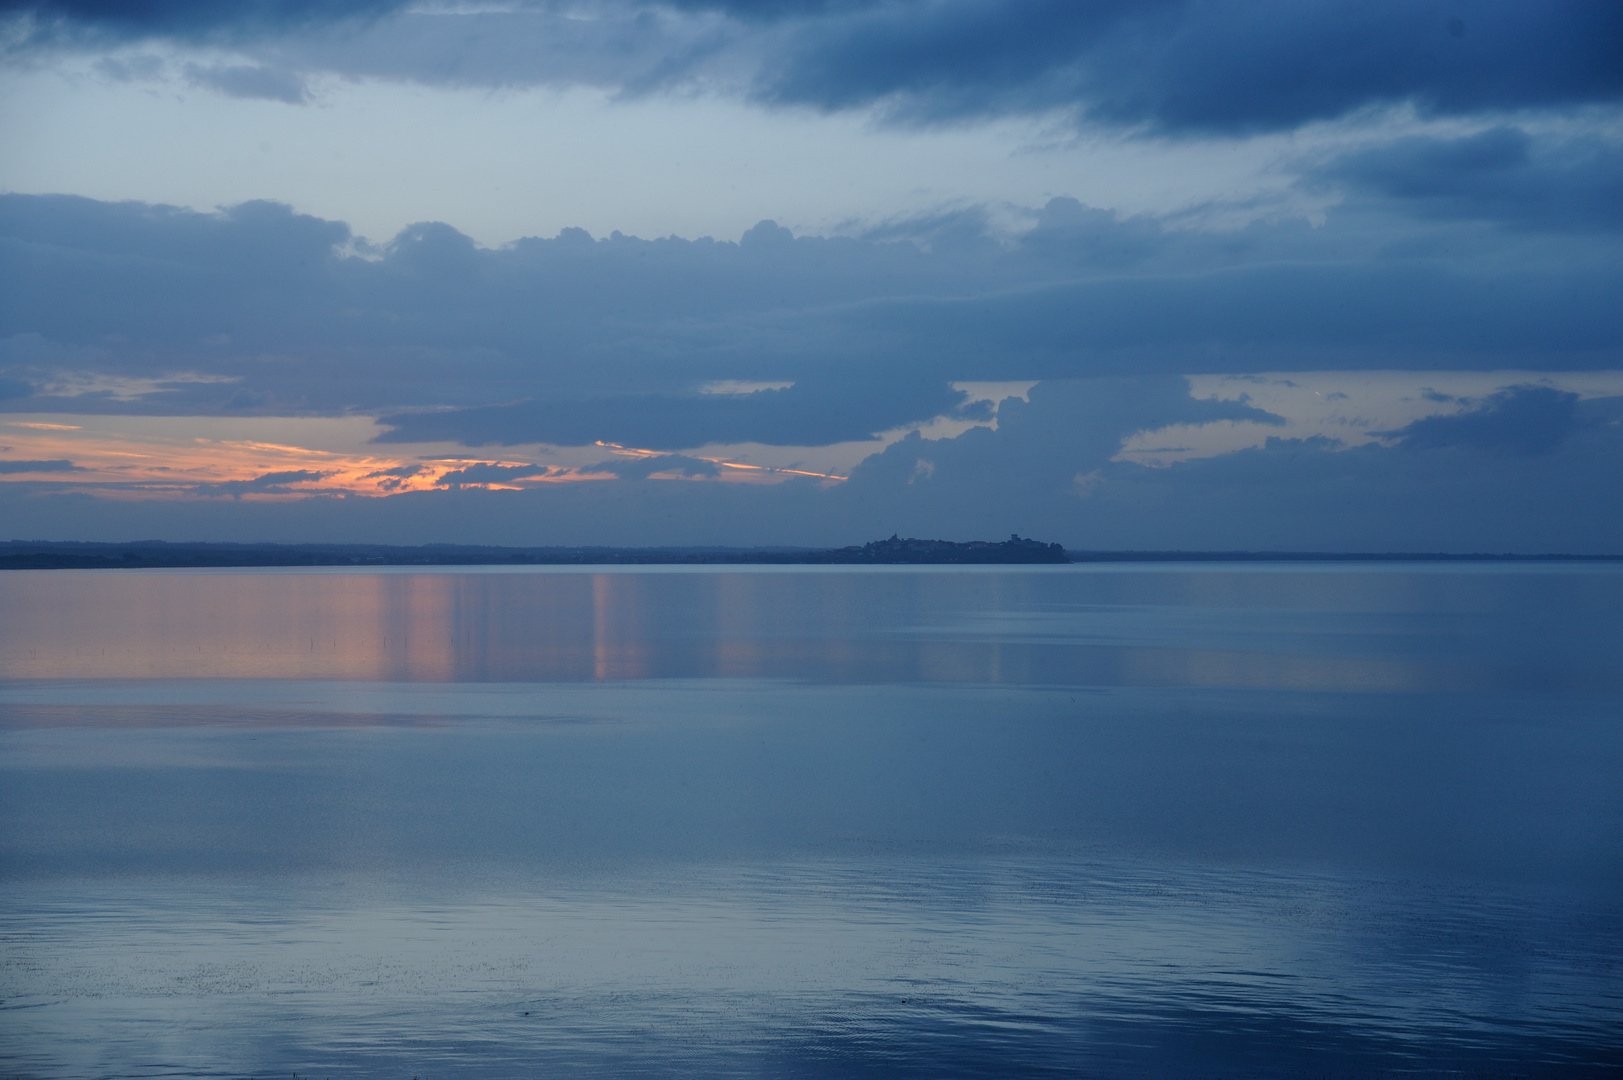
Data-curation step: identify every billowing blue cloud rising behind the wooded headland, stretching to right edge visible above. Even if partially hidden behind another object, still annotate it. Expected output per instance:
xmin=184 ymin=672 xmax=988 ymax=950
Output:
xmin=821 ymin=380 xmax=1623 ymax=554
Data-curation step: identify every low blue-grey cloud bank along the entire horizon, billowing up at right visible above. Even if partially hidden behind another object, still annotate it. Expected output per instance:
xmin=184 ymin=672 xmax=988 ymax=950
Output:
xmin=0 ymin=380 xmax=1623 ymax=554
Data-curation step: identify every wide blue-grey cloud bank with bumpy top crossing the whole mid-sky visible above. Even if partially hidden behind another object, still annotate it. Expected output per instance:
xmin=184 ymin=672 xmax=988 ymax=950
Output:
xmin=0 ymin=195 xmax=1623 ymax=450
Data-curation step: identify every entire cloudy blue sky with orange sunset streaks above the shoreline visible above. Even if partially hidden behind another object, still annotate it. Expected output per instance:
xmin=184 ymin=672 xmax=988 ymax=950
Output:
xmin=0 ymin=0 xmax=1623 ymax=554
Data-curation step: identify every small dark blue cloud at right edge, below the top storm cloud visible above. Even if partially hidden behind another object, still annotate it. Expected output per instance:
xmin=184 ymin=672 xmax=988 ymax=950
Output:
xmin=1318 ymin=127 xmax=1623 ymax=231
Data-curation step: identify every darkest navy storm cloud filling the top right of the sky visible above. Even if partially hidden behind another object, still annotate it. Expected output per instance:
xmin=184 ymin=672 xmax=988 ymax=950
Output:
xmin=746 ymin=0 xmax=1623 ymax=132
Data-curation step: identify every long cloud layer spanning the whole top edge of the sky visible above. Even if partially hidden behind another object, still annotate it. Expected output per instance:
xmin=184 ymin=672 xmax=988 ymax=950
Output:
xmin=5 ymin=0 xmax=1623 ymax=133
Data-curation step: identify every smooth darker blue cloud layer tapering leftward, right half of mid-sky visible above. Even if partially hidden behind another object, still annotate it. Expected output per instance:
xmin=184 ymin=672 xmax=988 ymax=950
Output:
xmin=799 ymin=258 xmax=1623 ymax=370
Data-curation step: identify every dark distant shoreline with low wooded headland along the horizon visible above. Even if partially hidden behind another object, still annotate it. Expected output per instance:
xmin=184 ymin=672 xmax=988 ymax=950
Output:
xmin=0 ymin=538 xmax=1623 ymax=570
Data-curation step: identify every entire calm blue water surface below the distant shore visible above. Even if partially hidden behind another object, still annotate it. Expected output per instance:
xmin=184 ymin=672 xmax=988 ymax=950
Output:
xmin=0 ymin=565 xmax=1623 ymax=1080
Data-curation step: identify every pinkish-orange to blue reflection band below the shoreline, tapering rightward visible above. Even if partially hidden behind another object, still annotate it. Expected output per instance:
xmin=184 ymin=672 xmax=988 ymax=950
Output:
xmin=0 ymin=570 xmax=1488 ymax=692
